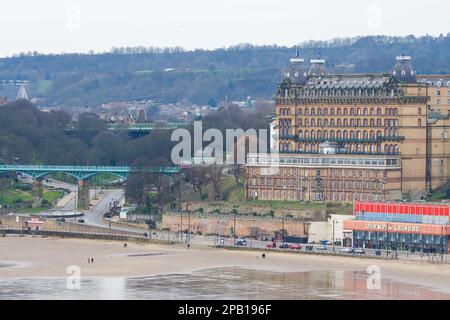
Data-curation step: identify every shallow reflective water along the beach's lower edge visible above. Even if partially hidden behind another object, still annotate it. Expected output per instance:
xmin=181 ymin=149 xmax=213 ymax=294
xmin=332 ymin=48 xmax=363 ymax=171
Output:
xmin=0 ymin=268 xmax=450 ymax=300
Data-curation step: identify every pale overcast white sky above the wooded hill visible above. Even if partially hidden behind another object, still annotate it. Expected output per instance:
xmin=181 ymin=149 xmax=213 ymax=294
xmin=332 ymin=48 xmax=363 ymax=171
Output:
xmin=0 ymin=0 xmax=450 ymax=57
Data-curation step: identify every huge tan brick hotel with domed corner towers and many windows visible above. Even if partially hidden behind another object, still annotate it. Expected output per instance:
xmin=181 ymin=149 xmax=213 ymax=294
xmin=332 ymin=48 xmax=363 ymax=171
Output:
xmin=246 ymin=54 xmax=450 ymax=201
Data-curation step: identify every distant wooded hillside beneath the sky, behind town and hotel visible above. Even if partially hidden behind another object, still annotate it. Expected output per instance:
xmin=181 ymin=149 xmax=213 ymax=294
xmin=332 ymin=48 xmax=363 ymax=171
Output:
xmin=0 ymin=35 xmax=450 ymax=106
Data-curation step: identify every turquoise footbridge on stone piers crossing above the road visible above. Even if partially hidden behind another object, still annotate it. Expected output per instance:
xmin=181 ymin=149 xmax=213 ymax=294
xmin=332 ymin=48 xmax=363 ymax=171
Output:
xmin=0 ymin=165 xmax=180 ymax=208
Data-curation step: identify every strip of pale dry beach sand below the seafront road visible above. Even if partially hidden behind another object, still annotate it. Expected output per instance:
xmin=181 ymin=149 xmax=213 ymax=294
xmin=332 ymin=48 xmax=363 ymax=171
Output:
xmin=0 ymin=237 xmax=450 ymax=298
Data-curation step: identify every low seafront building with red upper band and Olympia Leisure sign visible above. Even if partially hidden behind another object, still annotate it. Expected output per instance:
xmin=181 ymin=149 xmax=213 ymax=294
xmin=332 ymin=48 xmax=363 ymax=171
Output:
xmin=344 ymin=201 xmax=450 ymax=253
